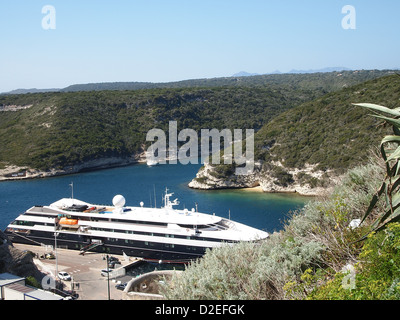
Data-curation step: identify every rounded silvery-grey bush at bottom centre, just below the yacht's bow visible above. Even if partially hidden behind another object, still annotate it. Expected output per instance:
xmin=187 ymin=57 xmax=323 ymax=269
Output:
xmin=162 ymin=234 xmax=321 ymax=300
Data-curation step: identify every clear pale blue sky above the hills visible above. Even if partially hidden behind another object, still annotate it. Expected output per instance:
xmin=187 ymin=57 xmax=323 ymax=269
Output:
xmin=0 ymin=0 xmax=400 ymax=92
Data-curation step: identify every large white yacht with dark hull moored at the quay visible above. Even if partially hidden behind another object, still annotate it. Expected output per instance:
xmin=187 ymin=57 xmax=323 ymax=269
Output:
xmin=5 ymin=190 xmax=268 ymax=262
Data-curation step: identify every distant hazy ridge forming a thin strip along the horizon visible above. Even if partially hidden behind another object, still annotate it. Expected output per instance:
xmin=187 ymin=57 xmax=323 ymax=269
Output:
xmin=3 ymin=68 xmax=394 ymax=94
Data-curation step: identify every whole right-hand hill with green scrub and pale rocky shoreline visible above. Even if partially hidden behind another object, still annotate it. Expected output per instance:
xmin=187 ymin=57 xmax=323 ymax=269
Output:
xmin=191 ymin=75 xmax=400 ymax=194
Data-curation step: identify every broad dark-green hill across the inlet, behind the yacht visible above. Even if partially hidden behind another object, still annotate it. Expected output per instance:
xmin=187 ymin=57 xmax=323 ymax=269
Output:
xmin=0 ymin=70 xmax=396 ymax=180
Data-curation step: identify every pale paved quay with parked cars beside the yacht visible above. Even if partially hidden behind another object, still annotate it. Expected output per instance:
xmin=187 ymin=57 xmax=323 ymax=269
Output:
xmin=14 ymin=243 xmax=137 ymax=300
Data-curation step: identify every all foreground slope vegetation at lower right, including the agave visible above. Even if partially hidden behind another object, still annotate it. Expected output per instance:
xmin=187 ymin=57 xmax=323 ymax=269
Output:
xmin=163 ymin=100 xmax=400 ymax=300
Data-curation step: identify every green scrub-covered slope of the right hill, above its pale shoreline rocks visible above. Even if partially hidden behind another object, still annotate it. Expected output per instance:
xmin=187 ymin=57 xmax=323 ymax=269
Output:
xmin=255 ymin=75 xmax=400 ymax=172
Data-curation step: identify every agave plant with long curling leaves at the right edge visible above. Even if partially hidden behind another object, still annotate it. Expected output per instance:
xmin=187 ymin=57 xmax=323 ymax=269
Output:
xmin=354 ymin=103 xmax=400 ymax=231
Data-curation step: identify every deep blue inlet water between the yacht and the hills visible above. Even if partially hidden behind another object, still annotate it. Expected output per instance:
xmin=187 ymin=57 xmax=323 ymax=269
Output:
xmin=0 ymin=164 xmax=309 ymax=232
